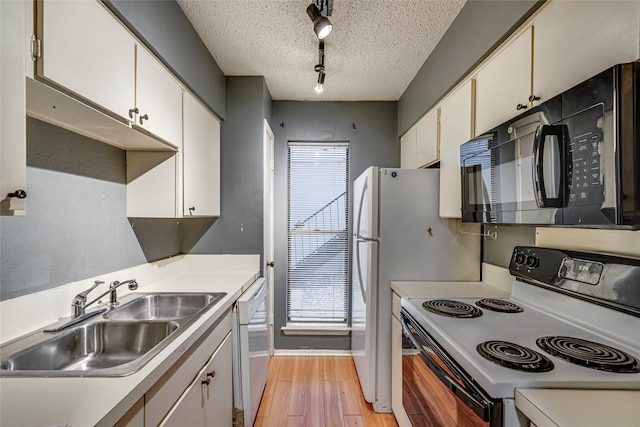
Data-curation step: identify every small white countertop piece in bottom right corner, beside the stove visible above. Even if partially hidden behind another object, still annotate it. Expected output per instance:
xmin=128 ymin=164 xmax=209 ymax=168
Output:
xmin=516 ymin=389 xmax=640 ymax=427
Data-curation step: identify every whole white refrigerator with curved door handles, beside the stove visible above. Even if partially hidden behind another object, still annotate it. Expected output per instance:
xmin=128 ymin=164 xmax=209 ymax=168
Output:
xmin=351 ymin=167 xmax=481 ymax=412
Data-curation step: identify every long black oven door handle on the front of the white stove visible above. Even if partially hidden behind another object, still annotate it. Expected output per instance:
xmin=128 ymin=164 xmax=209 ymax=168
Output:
xmin=400 ymin=310 xmax=490 ymax=421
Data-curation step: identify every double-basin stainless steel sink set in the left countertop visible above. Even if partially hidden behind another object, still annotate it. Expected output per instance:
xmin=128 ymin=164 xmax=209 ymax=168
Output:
xmin=0 ymin=292 xmax=226 ymax=377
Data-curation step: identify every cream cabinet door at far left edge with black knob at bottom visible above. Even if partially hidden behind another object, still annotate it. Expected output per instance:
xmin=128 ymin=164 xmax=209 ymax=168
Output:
xmin=0 ymin=1 xmax=27 ymax=215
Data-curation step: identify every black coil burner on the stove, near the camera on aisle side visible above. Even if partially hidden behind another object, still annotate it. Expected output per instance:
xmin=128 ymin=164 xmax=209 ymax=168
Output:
xmin=476 ymin=341 xmax=553 ymax=372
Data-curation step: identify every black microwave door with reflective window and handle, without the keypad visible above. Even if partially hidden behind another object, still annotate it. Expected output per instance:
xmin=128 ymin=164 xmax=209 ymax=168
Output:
xmin=460 ymin=123 xmax=570 ymax=224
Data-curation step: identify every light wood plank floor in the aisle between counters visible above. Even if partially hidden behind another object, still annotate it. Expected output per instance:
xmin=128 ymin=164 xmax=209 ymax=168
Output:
xmin=254 ymin=356 xmax=397 ymax=427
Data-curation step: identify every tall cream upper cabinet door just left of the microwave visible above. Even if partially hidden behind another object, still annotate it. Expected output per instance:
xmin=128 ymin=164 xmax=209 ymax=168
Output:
xmin=440 ymin=81 xmax=473 ymax=218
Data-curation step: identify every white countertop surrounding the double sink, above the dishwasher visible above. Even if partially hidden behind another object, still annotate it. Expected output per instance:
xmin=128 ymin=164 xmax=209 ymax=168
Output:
xmin=0 ymin=262 xmax=259 ymax=427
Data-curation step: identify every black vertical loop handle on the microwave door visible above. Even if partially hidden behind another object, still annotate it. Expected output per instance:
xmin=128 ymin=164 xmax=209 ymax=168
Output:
xmin=532 ymin=125 xmax=569 ymax=208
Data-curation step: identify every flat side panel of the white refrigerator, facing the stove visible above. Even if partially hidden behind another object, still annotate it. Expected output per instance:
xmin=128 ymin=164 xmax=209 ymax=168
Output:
xmin=367 ymin=169 xmax=480 ymax=412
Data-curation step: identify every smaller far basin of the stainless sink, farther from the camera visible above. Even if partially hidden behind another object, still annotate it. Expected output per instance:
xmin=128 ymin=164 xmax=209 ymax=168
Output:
xmin=103 ymin=293 xmax=226 ymax=320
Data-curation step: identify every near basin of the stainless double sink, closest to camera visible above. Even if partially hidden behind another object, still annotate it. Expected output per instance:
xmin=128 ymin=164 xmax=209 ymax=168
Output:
xmin=0 ymin=321 xmax=179 ymax=371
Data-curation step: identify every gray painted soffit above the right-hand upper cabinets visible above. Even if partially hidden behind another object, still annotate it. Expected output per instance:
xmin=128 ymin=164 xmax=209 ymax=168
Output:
xmin=398 ymin=0 xmax=543 ymax=136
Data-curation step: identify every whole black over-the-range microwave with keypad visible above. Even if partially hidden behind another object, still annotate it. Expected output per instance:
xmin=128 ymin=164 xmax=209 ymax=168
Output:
xmin=460 ymin=62 xmax=640 ymax=229
